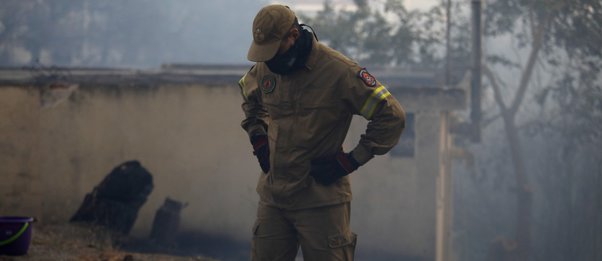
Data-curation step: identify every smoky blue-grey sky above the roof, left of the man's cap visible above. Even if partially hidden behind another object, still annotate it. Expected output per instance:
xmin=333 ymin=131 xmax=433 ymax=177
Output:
xmin=0 ymin=0 xmax=265 ymax=68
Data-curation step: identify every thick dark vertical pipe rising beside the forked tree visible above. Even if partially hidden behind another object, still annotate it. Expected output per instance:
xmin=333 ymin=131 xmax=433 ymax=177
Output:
xmin=470 ymin=0 xmax=482 ymax=142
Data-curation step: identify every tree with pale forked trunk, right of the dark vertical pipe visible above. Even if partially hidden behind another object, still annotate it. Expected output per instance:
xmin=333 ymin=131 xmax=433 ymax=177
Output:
xmin=484 ymin=0 xmax=602 ymax=260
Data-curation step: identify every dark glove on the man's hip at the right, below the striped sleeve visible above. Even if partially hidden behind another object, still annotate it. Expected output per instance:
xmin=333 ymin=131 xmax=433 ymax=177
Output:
xmin=309 ymin=150 xmax=360 ymax=186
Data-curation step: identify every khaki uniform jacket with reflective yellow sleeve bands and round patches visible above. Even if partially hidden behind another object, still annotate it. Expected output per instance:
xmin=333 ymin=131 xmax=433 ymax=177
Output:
xmin=239 ymin=36 xmax=405 ymax=209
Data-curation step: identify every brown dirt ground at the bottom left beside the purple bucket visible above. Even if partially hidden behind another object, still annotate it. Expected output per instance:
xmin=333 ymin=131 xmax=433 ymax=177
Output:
xmin=0 ymin=223 xmax=216 ymax=261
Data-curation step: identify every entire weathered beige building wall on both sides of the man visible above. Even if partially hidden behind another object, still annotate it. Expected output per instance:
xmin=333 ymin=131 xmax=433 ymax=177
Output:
xmin=0 ymin=85 xmax=439 ymax=259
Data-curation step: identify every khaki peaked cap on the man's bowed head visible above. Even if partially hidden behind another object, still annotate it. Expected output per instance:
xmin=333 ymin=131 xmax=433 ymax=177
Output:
xmin=247 ymin=5 xmax=296 ymax=62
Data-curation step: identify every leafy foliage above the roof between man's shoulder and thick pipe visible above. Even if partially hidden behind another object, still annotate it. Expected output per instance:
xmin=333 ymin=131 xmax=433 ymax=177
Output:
xmin=301 ymin=0 xmax=470 ymax=82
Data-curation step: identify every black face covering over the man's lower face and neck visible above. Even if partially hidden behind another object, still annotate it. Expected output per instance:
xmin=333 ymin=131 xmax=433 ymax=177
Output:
xmin=265 ymin=30 xmax=312 ymax=75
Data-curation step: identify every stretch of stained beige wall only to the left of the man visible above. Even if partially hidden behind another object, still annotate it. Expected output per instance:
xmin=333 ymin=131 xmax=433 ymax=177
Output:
xmin=0 ymin=86 xmax=258 ymax=238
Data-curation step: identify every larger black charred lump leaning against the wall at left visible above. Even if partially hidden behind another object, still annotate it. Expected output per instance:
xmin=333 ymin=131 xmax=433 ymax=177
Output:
xmin=70 ymin=160 xmax=153 ymax=234
